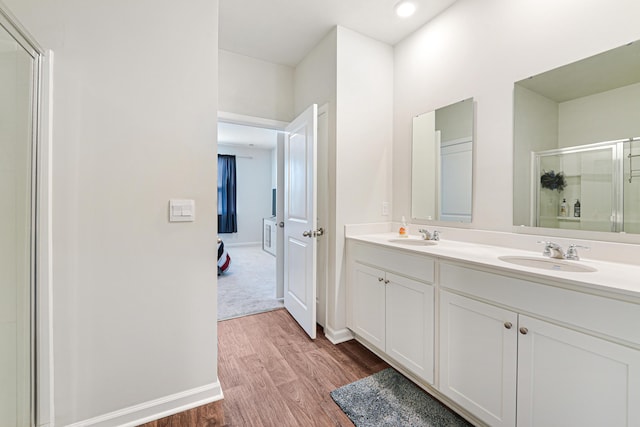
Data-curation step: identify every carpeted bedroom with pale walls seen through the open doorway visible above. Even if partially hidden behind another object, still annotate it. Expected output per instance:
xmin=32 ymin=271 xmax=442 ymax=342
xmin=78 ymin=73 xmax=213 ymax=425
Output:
xmin=218 ymin=122 xmax=283 ymax=320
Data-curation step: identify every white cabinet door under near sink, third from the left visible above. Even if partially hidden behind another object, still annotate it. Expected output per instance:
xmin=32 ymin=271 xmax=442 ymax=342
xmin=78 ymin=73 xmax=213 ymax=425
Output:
xmin=439 ymin=291 xmax=518 ymax=427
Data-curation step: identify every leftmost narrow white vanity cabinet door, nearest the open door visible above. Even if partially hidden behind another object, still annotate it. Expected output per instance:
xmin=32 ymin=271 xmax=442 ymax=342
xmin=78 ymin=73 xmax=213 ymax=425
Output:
xmin=351 ymin=262 xmax=385 ymax=351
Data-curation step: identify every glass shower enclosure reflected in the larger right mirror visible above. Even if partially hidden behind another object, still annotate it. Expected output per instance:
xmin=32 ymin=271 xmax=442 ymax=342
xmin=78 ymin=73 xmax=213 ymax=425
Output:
xmin=531 ymin=137 xmax=640 ymax=233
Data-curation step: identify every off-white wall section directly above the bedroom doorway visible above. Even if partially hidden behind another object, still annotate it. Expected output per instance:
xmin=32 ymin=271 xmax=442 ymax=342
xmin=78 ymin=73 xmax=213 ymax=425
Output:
xmin=218 ymin=49 xmax=294 ymax=122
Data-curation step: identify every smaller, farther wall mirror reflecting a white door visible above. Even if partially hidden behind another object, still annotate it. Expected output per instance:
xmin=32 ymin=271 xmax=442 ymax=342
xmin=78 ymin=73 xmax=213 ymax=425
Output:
xmin=411 ymin=98 xmax=474 ymax=222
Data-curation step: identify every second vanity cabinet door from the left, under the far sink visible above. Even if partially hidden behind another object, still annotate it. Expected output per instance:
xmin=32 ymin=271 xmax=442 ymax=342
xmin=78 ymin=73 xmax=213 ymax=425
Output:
xmin=386 ymin=273 xmax=434 ymax=384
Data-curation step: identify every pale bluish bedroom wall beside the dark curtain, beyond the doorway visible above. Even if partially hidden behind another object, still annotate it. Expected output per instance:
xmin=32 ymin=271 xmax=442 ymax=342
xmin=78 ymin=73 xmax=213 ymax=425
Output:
xmin=218 ymin=145 xmax=275 ymax=245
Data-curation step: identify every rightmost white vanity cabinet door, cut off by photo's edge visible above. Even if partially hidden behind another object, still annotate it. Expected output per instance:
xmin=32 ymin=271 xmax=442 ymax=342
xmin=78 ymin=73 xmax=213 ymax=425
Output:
xmin=518 ymin=315 xmax=640 ymax=427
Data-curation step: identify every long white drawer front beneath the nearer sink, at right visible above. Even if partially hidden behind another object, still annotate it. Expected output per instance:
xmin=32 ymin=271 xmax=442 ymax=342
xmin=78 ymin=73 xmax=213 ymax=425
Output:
xmin=440 ymin=263 xmax=640 ymax=345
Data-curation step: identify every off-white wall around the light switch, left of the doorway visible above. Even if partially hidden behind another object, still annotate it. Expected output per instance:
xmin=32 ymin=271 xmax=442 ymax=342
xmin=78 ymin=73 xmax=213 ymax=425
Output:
xmin=5 ymin=0 xmax=221 ymax=426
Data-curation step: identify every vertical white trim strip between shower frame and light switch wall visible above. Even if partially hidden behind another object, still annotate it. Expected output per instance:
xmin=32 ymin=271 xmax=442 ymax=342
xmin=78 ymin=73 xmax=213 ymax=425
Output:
xmin=35 ymin=51 xmax=54 ymax=426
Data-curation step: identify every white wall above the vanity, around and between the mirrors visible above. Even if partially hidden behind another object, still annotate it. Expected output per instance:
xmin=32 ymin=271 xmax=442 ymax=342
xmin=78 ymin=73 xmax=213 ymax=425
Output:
xmin=393 ymin=0 xmax=640 ymax=234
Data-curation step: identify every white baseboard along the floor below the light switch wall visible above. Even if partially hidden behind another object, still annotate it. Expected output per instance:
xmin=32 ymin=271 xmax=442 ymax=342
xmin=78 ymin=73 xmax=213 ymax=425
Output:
xmin=67 ymin=381 xmax=224 ymax=427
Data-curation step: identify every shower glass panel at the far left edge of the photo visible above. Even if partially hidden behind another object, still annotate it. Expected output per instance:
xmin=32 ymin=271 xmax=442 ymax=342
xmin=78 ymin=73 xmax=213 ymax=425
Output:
xmin=0 ymin=17 xmax=35 ymax=427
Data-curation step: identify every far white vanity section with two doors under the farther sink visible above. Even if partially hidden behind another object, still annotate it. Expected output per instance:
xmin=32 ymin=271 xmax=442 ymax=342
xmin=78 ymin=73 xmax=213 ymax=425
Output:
xmin=347 ymin=242 xmax=434 ymax=384
